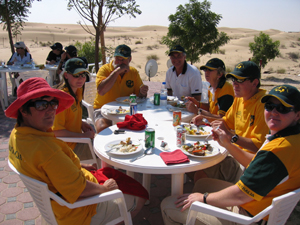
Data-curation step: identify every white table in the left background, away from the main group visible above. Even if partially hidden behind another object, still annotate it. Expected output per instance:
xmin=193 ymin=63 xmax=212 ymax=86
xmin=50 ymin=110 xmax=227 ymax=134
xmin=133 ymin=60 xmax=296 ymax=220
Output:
xmin=0 ymin=66 xmax=38 ymax=107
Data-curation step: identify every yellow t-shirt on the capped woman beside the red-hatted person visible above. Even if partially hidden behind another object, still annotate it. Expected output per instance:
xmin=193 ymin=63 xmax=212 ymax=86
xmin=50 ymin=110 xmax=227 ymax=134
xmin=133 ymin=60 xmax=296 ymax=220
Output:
xmin=52 ymin=88 xmax=83 ymax=149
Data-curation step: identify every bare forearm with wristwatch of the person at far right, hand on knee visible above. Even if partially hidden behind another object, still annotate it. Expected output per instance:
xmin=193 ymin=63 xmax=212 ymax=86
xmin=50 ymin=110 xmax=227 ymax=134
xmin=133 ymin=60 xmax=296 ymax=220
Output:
xmin=175 ymin=185 xmax=253 ymax=211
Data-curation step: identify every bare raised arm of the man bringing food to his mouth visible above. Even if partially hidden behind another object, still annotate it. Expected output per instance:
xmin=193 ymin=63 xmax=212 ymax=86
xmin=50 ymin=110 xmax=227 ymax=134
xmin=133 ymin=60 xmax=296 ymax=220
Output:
xmin=97 ymin=64 xmax=129 ymax=96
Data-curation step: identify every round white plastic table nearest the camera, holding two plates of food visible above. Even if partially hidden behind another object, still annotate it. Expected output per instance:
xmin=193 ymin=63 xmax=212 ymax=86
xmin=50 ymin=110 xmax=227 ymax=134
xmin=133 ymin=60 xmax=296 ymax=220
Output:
xmin=94 ymin=121 xmax=227 ymax=195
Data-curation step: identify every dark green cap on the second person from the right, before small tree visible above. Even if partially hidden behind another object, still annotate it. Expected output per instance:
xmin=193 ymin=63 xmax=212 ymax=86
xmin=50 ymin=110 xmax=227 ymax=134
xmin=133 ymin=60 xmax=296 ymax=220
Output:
xmin=226 ymin=61 xmax=260 ymax=79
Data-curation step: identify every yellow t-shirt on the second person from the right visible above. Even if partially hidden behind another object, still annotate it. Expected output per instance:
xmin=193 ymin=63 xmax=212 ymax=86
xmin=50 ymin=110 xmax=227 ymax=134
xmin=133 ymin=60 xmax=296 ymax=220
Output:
xmin=223 ymin=89 xmax=269 ymax=153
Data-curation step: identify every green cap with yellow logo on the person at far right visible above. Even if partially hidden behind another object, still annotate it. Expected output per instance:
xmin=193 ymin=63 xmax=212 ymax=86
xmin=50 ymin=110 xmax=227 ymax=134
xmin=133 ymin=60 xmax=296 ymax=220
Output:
xmin=261 ymin=85 xmax=300 ymax=108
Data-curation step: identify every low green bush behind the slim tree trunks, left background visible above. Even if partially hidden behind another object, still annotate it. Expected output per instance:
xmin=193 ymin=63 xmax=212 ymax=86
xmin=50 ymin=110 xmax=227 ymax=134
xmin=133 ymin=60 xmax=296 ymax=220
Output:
xmin=75 ymin=39 xmax=101 ymax=63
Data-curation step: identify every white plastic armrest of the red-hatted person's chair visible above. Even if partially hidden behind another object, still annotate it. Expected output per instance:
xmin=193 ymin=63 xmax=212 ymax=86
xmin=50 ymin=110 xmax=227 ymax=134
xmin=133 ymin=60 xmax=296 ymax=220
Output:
xmin=49 ymin=189 xmax=125 ymax=209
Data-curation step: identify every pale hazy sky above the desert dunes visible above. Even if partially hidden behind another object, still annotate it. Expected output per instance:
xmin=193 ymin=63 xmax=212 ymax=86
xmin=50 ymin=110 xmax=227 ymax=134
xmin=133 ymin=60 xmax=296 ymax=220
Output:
xmin=28 ymin=0 xmax=300 ymax=32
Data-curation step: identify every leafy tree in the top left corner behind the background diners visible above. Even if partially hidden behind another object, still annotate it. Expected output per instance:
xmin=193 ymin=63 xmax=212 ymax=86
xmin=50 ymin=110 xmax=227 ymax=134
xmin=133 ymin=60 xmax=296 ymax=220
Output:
xmin=0 ymin=0 xmax=40 ymax=54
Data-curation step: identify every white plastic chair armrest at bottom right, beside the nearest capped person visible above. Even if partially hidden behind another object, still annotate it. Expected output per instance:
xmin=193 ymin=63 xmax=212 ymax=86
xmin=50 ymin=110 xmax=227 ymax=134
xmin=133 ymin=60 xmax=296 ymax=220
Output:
xmin=186 ymin=201 xmax=271 ymax=225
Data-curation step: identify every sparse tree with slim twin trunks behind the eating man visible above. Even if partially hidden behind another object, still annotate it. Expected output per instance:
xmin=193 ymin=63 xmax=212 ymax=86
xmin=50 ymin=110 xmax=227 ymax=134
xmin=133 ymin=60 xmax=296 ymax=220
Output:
xmin=68 ymin=0 xmax=142 ymax=71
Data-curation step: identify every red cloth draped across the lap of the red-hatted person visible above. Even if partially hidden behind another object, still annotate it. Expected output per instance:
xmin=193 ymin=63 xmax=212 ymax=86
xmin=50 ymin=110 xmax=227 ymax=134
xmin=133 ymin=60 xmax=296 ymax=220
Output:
xmin=90 ymin=167 xmax=149 ymax=200
